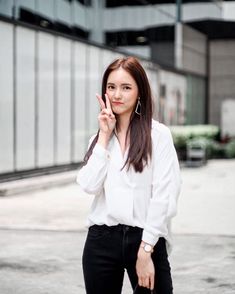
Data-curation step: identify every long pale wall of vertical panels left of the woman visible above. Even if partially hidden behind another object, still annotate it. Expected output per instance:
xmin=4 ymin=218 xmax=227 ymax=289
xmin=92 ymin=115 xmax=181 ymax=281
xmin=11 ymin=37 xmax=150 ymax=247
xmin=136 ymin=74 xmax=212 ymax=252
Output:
xmin=0 ymin=21 xmax=140 ymax=174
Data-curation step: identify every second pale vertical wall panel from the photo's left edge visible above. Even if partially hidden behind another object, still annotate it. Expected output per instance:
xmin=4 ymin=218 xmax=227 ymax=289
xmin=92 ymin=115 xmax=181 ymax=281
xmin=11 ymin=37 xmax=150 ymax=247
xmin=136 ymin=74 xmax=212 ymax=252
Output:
xmin=16 ymin=27 xmax=35 ymax=170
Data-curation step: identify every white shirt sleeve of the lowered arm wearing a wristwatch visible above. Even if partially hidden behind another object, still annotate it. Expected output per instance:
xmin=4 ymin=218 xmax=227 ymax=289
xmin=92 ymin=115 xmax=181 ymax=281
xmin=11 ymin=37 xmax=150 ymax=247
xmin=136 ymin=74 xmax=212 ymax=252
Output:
xmin=142 ymin=126 xmax=181 ymax=246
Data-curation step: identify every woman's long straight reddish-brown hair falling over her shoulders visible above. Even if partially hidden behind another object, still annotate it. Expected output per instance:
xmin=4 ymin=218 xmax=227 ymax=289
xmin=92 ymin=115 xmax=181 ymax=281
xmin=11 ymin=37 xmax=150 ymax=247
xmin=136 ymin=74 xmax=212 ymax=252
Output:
xmin=84 ymin=56 xmax=152 ymax=172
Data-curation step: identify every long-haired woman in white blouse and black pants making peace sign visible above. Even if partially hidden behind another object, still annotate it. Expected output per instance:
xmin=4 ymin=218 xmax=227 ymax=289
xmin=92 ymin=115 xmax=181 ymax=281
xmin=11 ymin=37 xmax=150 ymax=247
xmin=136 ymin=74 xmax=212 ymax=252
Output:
xmin=77 ymin=57 xmax=180 ymax=294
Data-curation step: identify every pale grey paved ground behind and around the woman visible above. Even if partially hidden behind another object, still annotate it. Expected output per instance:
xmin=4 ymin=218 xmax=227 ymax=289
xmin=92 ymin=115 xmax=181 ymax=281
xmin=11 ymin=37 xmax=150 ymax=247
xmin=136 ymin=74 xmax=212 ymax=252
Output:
xmin=0 ymin=160 xmax=235 ymax=294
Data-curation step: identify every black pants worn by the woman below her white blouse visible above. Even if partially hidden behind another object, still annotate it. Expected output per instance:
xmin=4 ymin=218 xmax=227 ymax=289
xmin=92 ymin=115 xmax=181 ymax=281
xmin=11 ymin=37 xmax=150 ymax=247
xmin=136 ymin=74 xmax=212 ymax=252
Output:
xmin=82 ymin=225 xmax=173 ymax=294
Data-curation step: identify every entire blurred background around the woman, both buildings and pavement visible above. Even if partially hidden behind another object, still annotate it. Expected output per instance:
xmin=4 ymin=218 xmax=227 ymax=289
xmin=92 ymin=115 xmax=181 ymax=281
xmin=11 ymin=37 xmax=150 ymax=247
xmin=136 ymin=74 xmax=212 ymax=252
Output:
xmin=0 ymin=0 xmax=235 ymax=294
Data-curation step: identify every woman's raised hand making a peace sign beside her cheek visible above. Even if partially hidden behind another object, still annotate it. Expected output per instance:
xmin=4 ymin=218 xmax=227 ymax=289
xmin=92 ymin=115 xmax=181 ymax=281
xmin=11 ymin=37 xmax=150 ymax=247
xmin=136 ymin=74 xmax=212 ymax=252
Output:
xmin=96 ymin=94 xmax=116 ymax=148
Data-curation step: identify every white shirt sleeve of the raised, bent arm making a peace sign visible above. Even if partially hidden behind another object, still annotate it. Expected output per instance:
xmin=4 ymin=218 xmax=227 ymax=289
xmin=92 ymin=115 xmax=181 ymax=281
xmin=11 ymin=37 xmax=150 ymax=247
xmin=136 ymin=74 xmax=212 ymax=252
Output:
xmin=76 ymin=140 xmax=110 ymax=194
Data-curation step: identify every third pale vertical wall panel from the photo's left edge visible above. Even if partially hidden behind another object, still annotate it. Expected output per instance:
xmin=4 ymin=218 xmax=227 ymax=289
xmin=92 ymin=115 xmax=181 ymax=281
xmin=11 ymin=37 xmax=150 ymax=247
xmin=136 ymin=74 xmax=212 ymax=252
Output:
xmin=37 ymin=32 xmax=54 ymax=167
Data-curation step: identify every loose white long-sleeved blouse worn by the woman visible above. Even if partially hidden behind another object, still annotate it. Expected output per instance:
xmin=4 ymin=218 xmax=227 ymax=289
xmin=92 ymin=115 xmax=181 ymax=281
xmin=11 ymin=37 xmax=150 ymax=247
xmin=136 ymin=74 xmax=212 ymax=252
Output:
xmin=77 ymin=120 xmax=181 ymax=253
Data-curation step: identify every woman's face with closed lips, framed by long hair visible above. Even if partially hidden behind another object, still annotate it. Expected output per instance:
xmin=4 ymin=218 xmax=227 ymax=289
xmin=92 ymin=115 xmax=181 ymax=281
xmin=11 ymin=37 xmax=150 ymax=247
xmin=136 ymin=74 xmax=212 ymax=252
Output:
xmin=106 ymin=67 xmax=138 ymax=115
